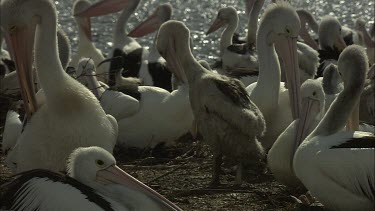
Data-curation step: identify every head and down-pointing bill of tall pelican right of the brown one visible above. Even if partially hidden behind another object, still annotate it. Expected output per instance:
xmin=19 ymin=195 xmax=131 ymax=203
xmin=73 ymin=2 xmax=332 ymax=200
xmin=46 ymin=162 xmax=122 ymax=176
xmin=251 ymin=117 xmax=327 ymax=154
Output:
xmin=257 ymin=2 xmax=301 ymax=119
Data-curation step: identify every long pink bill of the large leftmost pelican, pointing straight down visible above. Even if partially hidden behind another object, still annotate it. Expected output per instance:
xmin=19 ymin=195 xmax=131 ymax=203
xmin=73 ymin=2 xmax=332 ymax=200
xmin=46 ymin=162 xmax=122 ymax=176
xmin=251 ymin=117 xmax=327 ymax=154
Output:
xmin=6 ymin=25 xmax=37 ymax=118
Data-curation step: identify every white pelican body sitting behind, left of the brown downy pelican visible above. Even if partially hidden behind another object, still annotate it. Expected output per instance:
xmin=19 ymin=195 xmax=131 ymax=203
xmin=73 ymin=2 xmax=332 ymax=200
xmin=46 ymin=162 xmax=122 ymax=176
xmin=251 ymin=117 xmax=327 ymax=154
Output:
xmin=112 ymin=68 xmax=194 ymax=148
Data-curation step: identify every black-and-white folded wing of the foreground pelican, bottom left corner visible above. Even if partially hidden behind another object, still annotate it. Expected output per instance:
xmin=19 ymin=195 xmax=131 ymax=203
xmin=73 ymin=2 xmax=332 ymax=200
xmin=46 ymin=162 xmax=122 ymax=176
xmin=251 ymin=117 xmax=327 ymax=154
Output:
xmin=0 ymin=169 xmax=113 ymax=211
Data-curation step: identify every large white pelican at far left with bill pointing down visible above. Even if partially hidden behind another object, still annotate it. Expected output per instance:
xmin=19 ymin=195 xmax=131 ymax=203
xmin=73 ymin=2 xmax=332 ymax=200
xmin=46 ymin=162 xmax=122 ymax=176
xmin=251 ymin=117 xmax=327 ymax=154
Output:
xmin=0 ymin=0 xmax=117 ymax=172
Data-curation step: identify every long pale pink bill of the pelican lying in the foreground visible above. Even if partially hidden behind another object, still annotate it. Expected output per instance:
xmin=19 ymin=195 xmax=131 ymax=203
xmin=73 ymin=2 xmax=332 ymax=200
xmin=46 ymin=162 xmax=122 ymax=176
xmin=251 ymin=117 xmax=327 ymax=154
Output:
xmin=96 ymin=165 xmax=182 ymax=211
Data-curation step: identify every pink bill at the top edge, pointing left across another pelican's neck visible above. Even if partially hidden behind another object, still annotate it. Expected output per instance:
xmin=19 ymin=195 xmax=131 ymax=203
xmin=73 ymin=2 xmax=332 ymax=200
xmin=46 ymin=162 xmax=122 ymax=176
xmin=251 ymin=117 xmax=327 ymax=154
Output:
xmin=74 ymin=0 xmax=140 ymax=17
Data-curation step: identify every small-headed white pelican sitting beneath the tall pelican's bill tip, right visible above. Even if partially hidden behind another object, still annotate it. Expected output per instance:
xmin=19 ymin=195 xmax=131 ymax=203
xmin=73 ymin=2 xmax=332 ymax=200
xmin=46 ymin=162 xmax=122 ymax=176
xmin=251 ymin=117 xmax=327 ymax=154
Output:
xmin=267 ymin=79 xmax=324 ymax=187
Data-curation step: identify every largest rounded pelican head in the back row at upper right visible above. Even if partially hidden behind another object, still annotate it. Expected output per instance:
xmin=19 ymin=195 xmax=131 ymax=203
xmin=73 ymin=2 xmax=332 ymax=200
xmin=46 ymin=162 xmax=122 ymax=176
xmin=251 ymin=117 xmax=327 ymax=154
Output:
xmin=319 ymin=16 xmax=346 ymax=51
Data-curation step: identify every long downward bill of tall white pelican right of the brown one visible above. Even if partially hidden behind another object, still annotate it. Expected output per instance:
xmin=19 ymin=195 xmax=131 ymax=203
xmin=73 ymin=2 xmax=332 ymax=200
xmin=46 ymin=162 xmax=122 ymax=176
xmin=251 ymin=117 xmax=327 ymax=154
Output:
xmin=275 ymin=36 xmax=301 ymax=119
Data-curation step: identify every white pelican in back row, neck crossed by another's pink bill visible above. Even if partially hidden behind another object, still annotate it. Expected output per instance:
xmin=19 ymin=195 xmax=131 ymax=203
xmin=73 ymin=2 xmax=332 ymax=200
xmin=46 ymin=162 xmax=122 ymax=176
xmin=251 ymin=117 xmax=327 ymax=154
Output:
xmin=70 ymin=0 xmax=109 ymax=85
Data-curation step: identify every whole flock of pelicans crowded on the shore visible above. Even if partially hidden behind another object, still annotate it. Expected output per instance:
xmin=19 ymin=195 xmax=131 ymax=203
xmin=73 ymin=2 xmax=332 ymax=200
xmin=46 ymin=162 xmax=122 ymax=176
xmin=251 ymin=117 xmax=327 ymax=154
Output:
xmin=0 ymin=0 xmax=375 ymax=210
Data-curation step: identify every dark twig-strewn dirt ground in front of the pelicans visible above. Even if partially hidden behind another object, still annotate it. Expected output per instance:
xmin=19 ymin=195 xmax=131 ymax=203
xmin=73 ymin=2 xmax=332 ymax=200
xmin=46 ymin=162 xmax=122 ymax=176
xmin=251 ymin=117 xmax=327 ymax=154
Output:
xmin=0 ymin=96 xmax=323 ymax=211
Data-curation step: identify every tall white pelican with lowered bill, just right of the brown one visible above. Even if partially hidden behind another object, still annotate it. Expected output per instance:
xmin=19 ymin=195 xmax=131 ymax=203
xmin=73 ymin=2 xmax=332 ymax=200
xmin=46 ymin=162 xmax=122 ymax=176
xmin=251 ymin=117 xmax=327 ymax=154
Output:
xmin=246 ymin=2 xmax=301 ymax=149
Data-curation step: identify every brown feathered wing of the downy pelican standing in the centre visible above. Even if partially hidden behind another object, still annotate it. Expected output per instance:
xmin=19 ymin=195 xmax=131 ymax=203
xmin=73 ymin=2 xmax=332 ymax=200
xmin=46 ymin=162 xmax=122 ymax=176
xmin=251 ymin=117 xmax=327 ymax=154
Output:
xmin=204 ymin=77 xmax=265 ymax=136
